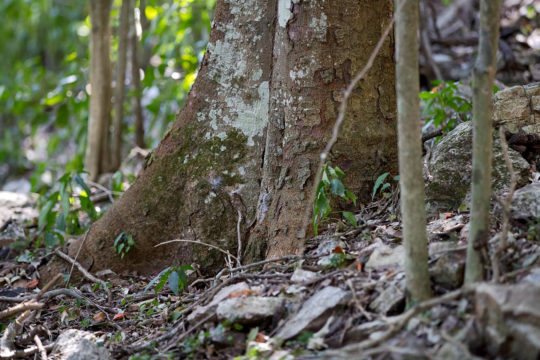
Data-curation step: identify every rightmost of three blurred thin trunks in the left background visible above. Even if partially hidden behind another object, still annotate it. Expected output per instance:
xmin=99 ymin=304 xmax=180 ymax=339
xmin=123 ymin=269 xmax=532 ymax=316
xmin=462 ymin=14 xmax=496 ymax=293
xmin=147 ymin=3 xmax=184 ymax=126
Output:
xmin=130 ymin=4 xmax=145 ymax=148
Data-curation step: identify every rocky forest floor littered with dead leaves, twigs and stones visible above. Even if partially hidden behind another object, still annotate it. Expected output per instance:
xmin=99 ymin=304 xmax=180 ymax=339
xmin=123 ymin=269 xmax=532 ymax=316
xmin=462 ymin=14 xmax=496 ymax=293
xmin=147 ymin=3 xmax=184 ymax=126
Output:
xmin=0 ymin=184 xmax=540 ymax=359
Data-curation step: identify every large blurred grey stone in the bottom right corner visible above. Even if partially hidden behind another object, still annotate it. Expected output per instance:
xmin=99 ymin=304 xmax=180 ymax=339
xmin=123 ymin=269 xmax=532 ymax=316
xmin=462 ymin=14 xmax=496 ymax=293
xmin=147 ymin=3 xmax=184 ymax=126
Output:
xmin=475 ymin=283 xmax=540 ymax=360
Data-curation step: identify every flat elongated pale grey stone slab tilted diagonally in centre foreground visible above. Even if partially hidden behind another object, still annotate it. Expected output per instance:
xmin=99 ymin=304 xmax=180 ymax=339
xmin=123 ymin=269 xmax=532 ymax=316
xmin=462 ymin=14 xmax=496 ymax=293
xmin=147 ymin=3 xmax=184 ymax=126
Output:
xmin=276 ymin=286 xmax=351 ymax=340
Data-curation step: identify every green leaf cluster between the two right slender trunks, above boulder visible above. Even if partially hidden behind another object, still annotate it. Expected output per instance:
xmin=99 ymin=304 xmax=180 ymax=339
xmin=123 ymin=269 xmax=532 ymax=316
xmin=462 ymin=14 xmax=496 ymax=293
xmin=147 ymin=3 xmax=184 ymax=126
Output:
xmin=420 ymin=81 xmax=472 ymax=136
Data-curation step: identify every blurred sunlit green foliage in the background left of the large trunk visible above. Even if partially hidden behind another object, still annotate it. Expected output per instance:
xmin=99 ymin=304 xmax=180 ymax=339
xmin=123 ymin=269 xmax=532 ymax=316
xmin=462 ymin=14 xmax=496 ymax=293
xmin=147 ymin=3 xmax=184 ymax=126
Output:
xmin=0 ymin=0 xmax=216 ymax=188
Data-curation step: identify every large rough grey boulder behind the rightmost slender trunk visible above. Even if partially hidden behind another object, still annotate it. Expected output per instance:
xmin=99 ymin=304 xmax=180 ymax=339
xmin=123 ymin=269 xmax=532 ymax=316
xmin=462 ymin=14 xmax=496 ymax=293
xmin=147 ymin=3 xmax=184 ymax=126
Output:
xmin=426 ymin=122 xmax=530 ymax=212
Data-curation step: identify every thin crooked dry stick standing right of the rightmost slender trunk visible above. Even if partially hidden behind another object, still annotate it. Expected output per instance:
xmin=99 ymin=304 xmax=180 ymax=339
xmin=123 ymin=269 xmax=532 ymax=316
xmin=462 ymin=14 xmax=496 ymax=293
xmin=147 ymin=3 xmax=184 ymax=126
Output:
xmin=491 ymin=126 xmax=517 ymax=283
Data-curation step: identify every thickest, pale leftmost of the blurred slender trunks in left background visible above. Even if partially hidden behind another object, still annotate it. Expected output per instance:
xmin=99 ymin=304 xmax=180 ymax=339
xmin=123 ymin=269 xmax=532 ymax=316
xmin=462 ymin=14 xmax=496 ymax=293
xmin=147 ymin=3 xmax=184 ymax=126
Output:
xmin=86 ymin=0 xmax=112 ymax=180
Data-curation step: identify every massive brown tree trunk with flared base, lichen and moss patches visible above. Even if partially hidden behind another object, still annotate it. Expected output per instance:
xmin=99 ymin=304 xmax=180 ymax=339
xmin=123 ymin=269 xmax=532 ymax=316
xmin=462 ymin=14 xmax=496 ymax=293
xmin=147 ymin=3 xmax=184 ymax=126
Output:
xmin=66 ymin=0 xmax=397 ymax=273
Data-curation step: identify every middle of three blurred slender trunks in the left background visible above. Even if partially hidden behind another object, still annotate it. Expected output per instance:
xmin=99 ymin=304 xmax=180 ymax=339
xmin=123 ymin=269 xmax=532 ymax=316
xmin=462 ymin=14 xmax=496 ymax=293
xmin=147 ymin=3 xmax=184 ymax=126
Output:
xmin=111 ymin=0 xmax=133 ymax=170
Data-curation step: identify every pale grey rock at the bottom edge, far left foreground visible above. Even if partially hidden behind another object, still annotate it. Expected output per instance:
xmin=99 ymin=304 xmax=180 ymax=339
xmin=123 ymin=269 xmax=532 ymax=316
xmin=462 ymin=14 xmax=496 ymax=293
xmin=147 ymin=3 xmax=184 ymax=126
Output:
xmin=50 ymin=329 xmax=111 ymax=360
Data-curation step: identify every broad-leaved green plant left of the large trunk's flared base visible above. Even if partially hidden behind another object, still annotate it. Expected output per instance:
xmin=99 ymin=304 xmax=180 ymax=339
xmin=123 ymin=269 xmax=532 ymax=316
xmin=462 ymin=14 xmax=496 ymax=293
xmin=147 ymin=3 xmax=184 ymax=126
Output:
xmin=38 ymin=173 xmax=99 ymax=247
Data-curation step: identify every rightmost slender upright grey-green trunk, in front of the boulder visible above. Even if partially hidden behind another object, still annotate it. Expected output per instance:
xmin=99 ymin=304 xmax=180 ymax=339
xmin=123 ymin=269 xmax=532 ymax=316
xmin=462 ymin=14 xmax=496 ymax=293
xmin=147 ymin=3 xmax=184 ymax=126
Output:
xmin=465 ymin=0 xmax=501 ymax=283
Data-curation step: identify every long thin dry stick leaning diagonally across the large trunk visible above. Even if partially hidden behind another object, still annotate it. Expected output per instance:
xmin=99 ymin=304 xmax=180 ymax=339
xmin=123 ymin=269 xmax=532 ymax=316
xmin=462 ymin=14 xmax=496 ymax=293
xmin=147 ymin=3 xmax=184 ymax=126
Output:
xmin=299 ymin=0 xmax=407 ymax=248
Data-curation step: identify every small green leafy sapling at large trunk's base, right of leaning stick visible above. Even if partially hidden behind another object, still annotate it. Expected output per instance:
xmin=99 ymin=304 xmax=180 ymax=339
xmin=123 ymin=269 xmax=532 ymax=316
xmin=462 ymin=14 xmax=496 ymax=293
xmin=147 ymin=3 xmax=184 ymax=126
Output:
xmin=313 ymin=164 xmax=358 ymax=236
